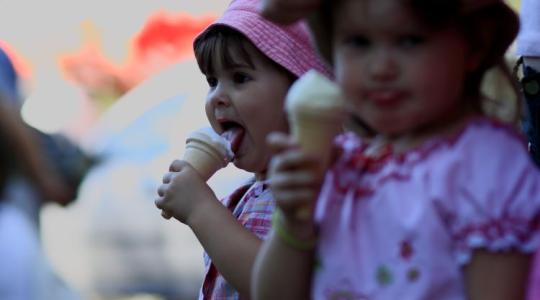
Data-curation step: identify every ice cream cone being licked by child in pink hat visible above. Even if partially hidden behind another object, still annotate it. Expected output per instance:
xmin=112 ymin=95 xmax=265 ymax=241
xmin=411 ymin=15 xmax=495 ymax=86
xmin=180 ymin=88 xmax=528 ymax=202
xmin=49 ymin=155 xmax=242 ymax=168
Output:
xmin=183 ymin=128 xmax=232 ymax=181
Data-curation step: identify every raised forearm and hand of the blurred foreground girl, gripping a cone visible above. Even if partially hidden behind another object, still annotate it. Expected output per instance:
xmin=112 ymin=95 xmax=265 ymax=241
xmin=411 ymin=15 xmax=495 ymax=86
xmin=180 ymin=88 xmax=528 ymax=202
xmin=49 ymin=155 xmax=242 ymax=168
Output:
xmin=252 ymin=133 xmax=321 ymax=300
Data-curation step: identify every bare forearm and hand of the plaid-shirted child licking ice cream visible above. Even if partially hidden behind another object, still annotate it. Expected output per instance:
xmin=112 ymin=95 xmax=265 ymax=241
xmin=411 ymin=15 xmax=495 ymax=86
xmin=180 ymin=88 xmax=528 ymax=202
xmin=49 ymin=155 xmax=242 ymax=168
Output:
xmin=156 ymin=160 xmax=261 ymax=295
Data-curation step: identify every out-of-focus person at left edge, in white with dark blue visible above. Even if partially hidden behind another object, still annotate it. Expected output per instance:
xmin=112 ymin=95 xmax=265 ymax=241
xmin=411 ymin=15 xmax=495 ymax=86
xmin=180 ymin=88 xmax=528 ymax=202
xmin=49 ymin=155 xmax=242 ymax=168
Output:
xmin=0 ymin=45 xmax=93 ymax=300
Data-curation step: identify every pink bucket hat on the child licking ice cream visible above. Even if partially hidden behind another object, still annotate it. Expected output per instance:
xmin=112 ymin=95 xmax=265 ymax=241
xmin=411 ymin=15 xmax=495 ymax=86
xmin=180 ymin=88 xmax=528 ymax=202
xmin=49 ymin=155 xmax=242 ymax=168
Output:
xmin=194 ymin=0 xmax=332 ymax=77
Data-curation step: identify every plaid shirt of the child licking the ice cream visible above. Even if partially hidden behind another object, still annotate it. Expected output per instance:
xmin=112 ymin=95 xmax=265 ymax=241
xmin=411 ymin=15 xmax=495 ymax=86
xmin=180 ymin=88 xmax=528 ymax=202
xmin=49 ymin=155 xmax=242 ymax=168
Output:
xmin=199 ymin=181 xmax=275 ymax=300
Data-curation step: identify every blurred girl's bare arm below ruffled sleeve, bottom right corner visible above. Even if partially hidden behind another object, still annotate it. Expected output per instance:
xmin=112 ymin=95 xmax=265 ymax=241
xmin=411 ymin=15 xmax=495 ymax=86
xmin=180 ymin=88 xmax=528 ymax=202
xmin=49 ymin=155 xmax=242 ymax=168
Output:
xmin=464 ymin=250 xmax=530 ymax=300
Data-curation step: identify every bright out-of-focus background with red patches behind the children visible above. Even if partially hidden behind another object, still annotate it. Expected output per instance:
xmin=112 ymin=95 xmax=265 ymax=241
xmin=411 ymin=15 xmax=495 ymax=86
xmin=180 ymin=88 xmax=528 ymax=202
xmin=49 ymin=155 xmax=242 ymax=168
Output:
xmin=0 ymin=0 xmax=519 ymax=299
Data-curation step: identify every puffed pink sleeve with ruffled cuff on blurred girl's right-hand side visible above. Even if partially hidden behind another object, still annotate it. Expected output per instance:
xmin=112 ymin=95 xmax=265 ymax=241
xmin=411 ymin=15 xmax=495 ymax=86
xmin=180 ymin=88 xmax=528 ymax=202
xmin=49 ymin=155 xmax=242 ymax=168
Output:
xmin=433 ymin=126 xmax=540 ymax=264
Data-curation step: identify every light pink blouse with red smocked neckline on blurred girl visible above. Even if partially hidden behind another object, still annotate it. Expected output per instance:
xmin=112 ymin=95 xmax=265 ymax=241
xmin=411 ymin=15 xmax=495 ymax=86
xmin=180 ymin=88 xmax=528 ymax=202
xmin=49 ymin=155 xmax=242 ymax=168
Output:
xmin=312 ymin=118 xmax=540 ymax=300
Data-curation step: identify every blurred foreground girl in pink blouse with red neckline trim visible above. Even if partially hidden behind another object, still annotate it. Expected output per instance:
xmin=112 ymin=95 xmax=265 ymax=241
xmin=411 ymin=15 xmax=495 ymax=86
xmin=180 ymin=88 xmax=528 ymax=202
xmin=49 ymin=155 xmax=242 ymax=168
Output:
xmin=252 ymin=0 xmax=540 ymax=300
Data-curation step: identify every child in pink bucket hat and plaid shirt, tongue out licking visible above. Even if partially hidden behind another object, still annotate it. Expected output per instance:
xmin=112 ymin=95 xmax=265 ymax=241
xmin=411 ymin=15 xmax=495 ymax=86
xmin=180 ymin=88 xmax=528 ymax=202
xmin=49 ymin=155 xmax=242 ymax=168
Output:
xmin=152 ymin=0 xmax=329 ymax=299
